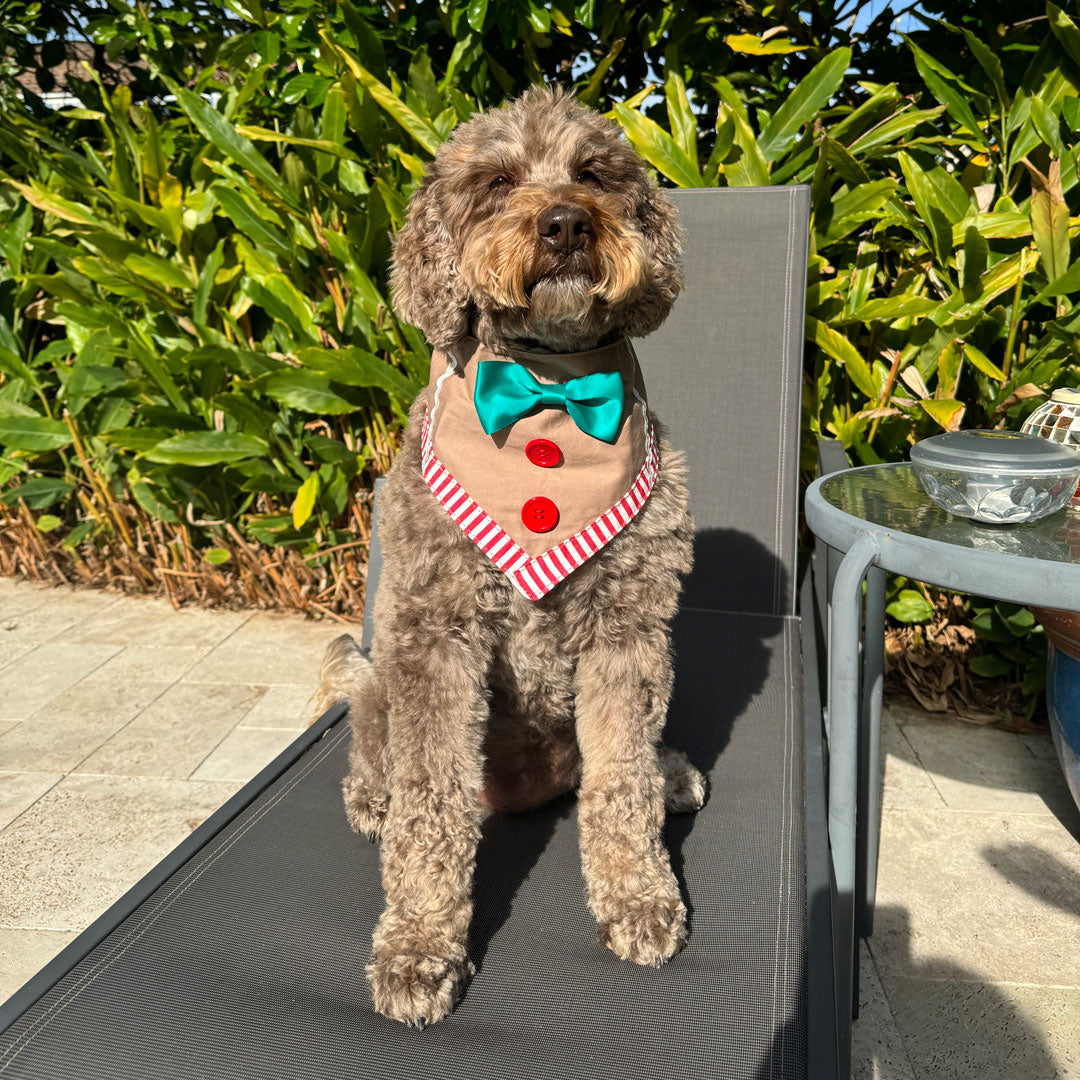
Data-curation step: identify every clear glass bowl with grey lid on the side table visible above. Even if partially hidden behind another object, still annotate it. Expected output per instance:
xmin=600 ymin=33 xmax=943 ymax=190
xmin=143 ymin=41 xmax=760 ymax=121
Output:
xmin=912 ymin=430 xmax=1080 ymax=525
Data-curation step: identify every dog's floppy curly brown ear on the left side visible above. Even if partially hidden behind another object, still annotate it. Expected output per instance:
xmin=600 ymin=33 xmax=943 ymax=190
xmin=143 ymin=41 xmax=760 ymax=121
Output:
xmin=390 ymin=166 xmax=469 ymax=349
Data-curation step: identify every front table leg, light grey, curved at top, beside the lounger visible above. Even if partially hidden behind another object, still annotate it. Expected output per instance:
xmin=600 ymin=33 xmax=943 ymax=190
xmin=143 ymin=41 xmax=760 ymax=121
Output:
xmin=828 ymin=535 xmax=878 ymax=1077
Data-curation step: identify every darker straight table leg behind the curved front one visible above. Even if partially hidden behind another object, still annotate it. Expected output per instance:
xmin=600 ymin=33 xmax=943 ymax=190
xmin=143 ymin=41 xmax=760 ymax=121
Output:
xmin=855 ymin=566 xmax=885 ymax=937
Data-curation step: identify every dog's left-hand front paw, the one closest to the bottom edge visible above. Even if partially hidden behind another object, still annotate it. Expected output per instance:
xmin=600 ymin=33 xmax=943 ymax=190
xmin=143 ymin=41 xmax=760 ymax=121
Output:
xmin=367 ymin=951 xmax=474 ymax=1028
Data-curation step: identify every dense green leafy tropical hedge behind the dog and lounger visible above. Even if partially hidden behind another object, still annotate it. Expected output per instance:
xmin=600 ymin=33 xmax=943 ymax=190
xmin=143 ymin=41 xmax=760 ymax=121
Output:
xmin=0 ymin=0 xmax=1080 ymax=691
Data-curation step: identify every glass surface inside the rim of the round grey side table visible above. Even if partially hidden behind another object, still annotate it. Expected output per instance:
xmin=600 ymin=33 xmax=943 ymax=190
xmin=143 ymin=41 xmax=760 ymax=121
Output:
xmin=814 ymin=462 xmax=1080 ymax=564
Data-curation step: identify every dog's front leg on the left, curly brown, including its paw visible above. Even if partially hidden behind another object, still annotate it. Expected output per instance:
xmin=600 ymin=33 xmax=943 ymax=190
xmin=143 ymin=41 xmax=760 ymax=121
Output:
xmin=367 ymin=623 xmax=490 ymax=1027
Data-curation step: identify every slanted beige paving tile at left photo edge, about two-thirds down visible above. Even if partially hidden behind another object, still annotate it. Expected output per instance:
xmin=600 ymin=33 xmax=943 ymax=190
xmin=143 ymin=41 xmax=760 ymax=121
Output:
xmin=0 ymin=678 xmax=168 ymax=772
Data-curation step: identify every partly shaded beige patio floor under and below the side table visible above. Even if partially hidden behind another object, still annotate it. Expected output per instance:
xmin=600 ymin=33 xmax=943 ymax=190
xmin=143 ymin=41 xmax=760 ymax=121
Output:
xmin=853 ymin=706 xmax=1080 ymax=1080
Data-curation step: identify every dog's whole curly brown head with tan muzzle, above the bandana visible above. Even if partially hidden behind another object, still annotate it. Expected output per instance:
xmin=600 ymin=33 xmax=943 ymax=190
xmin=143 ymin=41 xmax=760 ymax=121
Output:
xmin=391 ymin=89 xmax=683 ymax=350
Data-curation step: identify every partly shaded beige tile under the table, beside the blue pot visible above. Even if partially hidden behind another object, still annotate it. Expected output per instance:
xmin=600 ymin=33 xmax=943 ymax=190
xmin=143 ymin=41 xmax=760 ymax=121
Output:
xmin=901 ymin=716 xmax=1076 ymax=816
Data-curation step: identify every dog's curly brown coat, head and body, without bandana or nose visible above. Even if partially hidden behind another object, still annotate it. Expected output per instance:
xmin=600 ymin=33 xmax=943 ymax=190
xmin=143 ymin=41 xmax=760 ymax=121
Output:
xmin=320 ymin=90 xmax=704 ymax=1027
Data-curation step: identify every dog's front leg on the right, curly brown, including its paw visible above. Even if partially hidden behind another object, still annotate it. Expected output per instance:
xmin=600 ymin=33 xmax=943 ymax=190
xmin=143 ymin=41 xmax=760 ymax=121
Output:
xmin=576 ymin=622 xmax=686 ymax=967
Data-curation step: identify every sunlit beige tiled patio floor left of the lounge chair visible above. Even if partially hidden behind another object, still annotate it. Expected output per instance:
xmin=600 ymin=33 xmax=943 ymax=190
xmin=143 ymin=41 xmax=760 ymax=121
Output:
xmin=0 ymin=578 xmax=342 ymax=1000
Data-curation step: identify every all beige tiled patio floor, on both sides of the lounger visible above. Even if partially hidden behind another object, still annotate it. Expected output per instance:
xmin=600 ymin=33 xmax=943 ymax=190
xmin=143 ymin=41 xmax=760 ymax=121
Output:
xmin=0 ymin=579 xmax=1080 ymax=1080
